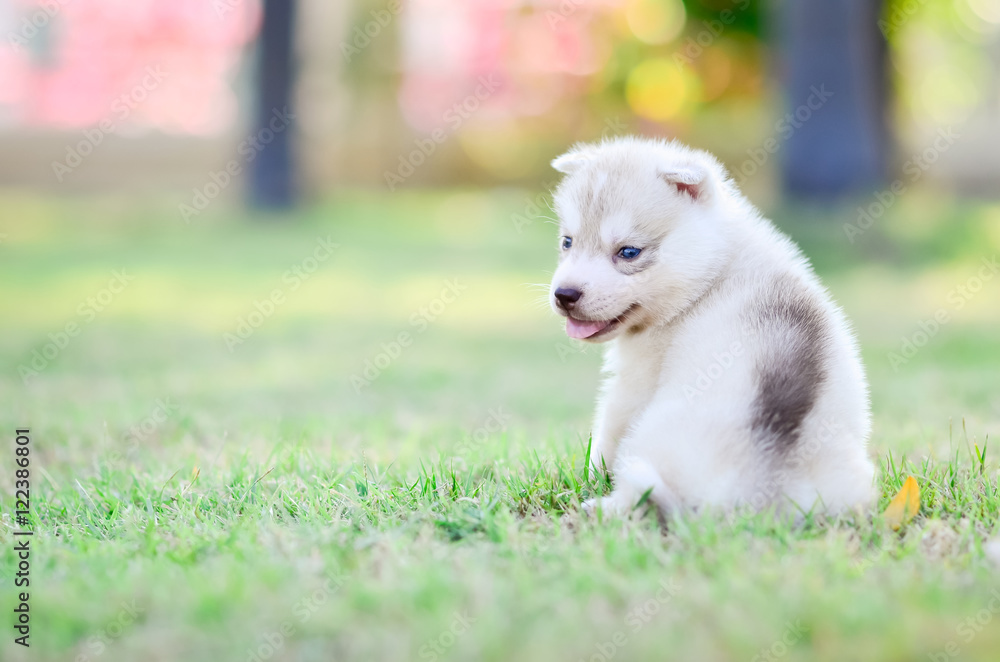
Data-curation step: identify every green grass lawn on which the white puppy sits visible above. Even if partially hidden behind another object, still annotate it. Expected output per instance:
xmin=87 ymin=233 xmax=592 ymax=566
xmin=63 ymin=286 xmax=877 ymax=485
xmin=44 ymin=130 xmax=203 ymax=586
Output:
xmin=0 ymin=191 xmax=1000 ymax=662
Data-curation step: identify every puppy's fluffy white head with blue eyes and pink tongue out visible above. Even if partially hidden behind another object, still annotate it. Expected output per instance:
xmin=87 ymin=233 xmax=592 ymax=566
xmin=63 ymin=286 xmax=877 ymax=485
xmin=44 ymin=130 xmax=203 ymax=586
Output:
xmin=551 ymin=138 xmax=726 ymax=342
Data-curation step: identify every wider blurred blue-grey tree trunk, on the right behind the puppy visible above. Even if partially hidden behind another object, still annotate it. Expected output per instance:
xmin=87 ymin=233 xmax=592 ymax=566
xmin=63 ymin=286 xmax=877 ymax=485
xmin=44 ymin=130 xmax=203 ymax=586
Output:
xmin=780 ymin=0 xmax=889 ymax=199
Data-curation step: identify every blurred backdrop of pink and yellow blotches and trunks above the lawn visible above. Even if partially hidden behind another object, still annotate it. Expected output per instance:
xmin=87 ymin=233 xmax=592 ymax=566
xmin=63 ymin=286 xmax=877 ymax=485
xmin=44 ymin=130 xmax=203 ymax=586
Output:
xmin=0 ymin=0 xmax=1000 ymax=203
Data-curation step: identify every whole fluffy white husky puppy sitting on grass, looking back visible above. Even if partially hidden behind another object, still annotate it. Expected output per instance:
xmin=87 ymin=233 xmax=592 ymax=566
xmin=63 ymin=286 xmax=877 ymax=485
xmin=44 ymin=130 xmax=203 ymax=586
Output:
xmin=551 ymin=138 xmax=874 ymax=515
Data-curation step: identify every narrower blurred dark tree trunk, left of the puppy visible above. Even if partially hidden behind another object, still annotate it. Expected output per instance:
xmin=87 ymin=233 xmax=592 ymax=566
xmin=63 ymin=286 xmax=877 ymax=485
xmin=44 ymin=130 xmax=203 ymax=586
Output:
xmin=250 ymin=0 xmax=298 ymax=209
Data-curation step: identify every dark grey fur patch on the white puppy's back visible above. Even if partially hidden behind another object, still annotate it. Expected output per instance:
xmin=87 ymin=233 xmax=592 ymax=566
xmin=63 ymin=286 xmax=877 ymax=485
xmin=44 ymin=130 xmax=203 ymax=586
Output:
xmin=746 ymin=277 xmax=829 ymax=457
